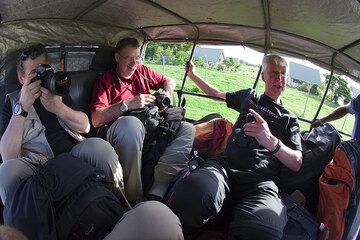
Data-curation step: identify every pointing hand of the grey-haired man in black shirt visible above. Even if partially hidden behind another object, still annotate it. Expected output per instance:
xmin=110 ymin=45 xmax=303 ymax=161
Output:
xmin=243 ymin=109 xmax=275 ymax=149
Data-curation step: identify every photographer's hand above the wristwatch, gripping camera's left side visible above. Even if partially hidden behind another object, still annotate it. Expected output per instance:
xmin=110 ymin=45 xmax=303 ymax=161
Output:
xmin=19 ymin=75 xmax=41 ymax=112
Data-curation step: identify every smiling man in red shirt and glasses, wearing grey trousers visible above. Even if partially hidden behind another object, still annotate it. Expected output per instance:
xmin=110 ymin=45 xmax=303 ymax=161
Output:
xmin=91 ymin=38 xmax=195 ymax=201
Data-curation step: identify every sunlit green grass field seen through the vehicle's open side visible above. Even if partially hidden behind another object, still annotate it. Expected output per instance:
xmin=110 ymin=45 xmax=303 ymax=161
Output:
xmin=146 ymin=64 xmax=355 ymax=138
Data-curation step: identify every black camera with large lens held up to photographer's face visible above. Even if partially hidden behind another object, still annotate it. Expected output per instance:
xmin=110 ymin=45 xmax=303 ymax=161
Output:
xmin=31 ymin=64 xmax=71 ymax=96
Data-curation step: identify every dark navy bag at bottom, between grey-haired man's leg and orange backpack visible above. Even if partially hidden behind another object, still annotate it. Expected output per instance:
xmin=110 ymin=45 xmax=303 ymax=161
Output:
xmin=281 ymin=193 xmax=319 ymax=240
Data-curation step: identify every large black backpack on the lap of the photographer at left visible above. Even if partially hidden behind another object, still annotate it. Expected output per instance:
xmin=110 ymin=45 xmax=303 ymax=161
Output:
xmin=4 ymin=154 xmax=125 ymax=240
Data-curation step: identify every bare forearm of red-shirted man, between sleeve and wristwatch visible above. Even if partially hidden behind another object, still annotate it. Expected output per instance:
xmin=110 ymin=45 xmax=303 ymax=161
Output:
xmin=91 ymin=103 xmax=122 ymax=128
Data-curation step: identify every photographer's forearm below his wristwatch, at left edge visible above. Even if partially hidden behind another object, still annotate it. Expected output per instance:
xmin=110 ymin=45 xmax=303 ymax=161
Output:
xmin=0 ymin=115 xmax=25 ymax=161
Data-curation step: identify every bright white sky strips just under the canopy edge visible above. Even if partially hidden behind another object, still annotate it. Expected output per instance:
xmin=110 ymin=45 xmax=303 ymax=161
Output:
xmin=201 ymin=45 xmax=360 ymax=97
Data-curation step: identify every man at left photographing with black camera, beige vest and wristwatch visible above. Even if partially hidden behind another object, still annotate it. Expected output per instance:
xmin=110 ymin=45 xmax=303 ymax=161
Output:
xmin=0 ymin=45 xmax=123 ymax=204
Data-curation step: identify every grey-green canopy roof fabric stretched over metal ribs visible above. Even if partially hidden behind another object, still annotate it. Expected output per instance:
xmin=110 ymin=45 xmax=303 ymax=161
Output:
xmin=0 ymin=0 xmax=360 ymax=82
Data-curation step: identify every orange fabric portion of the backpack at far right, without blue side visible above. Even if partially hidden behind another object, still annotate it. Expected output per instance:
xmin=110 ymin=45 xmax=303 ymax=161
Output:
xmin=317 ymin=148 xmax=355 ymax=239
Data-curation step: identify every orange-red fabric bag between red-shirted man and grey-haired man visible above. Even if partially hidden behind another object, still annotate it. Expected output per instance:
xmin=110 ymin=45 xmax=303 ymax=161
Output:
xmin=193 ymin=118 xmax=233 ymax=157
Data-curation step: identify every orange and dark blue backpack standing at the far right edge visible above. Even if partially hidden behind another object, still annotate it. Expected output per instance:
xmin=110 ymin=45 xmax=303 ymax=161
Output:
xmin=317 ymin=140 xmax=360 ymax=240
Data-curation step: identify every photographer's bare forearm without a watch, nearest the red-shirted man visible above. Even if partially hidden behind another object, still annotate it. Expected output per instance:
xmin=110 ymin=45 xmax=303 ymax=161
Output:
xmin=57 ymin=104 xmax=90 ymax=133
